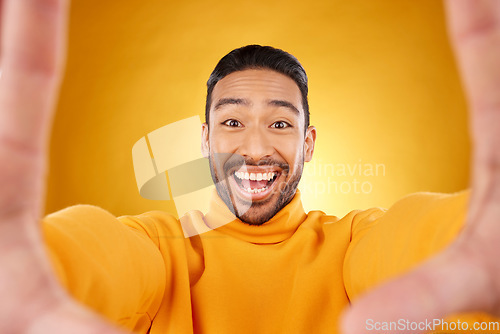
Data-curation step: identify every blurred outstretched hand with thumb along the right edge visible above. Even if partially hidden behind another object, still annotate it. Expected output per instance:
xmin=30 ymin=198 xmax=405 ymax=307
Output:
xmin=343 ymin=0 xmax=500 ymax=334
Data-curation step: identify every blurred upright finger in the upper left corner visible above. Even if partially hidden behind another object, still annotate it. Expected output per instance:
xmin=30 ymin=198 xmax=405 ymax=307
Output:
xmin=0 ymin=0 xmax=68 ymax=151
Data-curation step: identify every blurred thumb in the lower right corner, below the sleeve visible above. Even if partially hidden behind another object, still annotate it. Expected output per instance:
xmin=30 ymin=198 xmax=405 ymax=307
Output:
xmin=342 ymin=244 xmax=492 ymax=334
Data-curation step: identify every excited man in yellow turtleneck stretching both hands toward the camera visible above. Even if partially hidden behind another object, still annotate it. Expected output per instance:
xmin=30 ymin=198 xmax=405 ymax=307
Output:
xmin=0 ymin=0 xmax=500 ymax=333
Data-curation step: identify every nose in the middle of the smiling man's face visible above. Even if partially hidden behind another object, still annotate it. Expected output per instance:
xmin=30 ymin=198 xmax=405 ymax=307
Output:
xmin=238 ymin=127 xmax=274 ymax=162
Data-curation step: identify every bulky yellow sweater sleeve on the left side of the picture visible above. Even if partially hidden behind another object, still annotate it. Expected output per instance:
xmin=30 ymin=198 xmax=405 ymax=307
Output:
xmin=42 ymin=205 xmax=166 ymax=333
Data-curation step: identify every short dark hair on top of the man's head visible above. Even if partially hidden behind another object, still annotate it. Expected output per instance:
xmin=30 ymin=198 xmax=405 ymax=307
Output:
xmin=205 ymin=45 xmax=309 ymax=129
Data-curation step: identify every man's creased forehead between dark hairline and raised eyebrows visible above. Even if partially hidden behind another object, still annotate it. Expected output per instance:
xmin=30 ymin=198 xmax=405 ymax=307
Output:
xmin=211 ymin=69 xmax=304 ymax=114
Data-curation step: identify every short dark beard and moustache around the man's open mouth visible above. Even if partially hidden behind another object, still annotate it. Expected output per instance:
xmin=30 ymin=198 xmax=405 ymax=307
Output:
xmin=209 ymin=153 xmax=304 ymax=225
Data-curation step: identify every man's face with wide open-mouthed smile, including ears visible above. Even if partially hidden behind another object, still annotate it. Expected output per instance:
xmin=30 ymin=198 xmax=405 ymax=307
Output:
xmin=202 ymin=69 xmax=316 ymax=225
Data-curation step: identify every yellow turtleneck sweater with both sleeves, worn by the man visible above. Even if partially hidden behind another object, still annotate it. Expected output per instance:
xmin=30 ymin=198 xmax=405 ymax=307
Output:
xmin=43 ymin=192 xmax=494 ymax=334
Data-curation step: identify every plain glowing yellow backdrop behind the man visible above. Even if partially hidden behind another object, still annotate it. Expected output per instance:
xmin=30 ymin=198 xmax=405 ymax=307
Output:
xmin=46 ymin=0 xmax=470 ymax=215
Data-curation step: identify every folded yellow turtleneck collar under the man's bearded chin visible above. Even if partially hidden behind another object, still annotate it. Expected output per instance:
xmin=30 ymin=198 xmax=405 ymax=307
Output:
xmin=205 ymin=189 xmax=306 ymax=244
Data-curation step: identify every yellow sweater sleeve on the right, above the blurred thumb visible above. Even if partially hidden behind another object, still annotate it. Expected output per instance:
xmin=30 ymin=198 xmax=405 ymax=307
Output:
xmin=344 ymin=191 xmax=468 ymax=300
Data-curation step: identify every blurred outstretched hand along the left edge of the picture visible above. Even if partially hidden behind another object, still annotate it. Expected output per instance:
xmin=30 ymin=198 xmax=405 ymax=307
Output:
xmin=0 ymin=0 xmax=122 ymax=333
